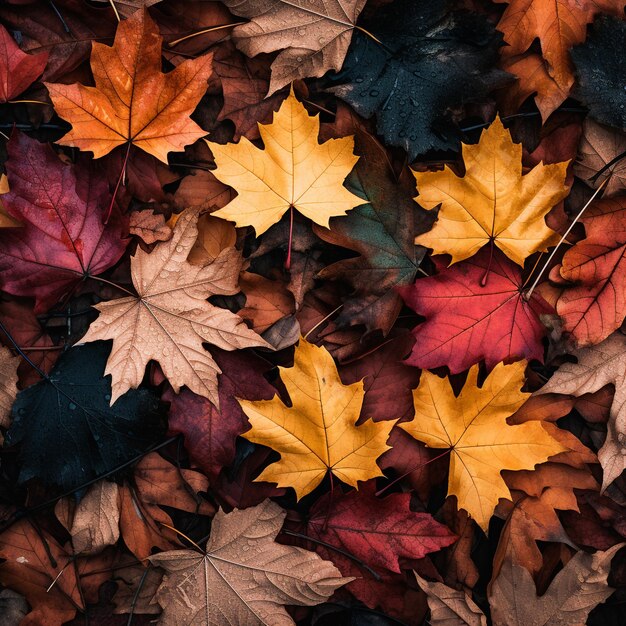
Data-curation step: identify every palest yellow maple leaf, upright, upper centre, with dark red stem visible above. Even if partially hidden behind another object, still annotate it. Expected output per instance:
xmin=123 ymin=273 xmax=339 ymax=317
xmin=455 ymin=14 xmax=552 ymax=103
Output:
xmin=207 ymin=89 xmax=365 ymax=235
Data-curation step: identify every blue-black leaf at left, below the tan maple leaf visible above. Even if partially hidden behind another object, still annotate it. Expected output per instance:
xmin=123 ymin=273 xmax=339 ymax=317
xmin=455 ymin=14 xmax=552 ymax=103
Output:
xmin=5 ymin=342 xmax=165 ymax=490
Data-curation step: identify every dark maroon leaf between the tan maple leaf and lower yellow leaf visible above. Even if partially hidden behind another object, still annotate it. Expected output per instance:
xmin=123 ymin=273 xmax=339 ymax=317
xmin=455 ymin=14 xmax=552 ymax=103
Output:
xmin=163 ymin=349 xmax=276 ymax=480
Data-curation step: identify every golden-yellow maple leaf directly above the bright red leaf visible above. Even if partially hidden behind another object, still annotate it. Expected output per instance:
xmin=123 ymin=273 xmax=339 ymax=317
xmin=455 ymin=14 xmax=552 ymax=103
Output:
xmin=413 ymin=117 xmax=569 ymax=265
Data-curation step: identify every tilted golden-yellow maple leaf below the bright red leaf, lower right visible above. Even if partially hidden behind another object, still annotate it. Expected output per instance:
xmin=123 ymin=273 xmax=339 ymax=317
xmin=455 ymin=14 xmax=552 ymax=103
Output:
xmin=399 ymin=361 xmax=567 ymax=531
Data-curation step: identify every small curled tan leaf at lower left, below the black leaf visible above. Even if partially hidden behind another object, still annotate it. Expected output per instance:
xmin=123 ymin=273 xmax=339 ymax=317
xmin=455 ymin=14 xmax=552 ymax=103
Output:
xmin=70 ymin=480 xmax=120 ymax=554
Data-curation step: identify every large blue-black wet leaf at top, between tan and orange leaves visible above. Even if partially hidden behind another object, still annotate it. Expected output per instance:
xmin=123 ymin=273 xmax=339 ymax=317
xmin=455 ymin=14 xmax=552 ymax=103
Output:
xmin=332 ymin=0 xmax=510 ymax=161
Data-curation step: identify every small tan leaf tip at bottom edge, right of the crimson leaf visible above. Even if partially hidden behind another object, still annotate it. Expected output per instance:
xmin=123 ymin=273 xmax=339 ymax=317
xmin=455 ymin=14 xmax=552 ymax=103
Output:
xmin=413 ymin=572 xmax=487 ymax=626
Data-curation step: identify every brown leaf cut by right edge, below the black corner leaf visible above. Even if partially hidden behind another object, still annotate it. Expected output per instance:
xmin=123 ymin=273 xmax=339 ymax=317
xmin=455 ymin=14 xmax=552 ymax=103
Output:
xmin=574 ymin=119 xmax=626 ymax=198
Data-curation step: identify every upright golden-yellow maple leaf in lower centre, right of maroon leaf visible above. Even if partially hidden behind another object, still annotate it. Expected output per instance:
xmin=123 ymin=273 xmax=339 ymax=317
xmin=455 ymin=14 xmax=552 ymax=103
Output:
xmin=238 ymin=338 xmax=396 ymax=499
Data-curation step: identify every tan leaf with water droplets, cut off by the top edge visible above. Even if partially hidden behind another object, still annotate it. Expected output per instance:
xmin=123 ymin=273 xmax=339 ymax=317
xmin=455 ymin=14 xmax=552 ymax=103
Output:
xmin=224 ymin=0 xmax=365 ymax=95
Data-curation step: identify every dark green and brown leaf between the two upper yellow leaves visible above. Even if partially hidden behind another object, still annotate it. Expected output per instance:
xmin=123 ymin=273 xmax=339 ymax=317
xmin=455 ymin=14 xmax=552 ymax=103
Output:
xmin=313 ymin=132 xmax=434 ymax=335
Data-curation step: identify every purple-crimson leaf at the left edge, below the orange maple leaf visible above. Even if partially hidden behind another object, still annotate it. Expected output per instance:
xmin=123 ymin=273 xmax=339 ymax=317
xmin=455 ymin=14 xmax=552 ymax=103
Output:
xmin=0 ymin=133 xmax=128 ymax=313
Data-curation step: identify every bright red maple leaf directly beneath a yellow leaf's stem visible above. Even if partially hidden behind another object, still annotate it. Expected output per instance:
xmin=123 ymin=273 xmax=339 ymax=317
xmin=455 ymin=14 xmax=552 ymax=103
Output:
xmin=400 ymin=250 xmax=553 ymax=374
